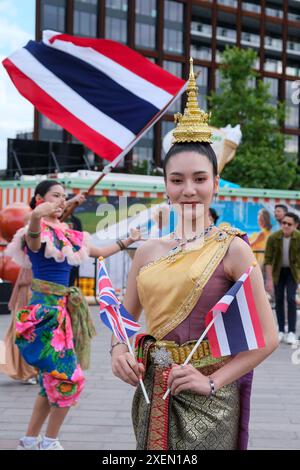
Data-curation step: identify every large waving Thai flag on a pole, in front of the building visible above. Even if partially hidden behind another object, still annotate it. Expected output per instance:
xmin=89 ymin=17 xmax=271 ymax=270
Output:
xmin=3 ymin=31 xmax=185 ymax=161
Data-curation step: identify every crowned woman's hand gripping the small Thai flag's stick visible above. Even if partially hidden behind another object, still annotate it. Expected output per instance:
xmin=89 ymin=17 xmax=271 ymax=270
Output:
xmin=168 ymin=364 xmax=211 ymax=396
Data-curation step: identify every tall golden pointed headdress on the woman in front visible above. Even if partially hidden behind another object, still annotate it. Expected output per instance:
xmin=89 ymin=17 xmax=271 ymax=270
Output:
xmin=172 ymin=58 xmax=212 ymax=144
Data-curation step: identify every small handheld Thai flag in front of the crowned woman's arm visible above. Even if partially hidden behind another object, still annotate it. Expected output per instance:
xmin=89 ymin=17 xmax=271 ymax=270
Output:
xmin=205 ymin=266 xmax=265 ymax=357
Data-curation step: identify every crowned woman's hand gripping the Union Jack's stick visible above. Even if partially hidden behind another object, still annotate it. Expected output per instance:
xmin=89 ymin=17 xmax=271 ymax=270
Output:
xmin=112 ymin=344 xmax=145 ymax=387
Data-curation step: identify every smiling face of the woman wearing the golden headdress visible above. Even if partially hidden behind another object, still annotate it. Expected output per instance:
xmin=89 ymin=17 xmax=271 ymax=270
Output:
xmin=166 ymin=151 xmax=219 ymax=217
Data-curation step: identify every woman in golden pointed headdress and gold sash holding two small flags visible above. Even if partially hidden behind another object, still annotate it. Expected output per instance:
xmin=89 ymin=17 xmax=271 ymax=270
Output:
xmin=111 ymin=60 xmax=278 ymax=450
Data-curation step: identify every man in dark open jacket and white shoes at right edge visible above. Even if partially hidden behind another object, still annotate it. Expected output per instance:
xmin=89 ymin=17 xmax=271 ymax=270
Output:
xmin=265 ymin=212 xmax=300 ymax=344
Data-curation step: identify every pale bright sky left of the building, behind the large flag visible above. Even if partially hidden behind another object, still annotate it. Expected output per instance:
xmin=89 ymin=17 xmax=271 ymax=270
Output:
xmin=0 ymin=0 xmax=35 ymax=168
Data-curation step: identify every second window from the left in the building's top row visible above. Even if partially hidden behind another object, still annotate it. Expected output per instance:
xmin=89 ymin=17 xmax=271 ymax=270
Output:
xmin=73 ymin=0 xmax=97 ymax=37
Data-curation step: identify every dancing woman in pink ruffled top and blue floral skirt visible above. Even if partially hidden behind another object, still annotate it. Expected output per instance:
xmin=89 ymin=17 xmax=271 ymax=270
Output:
xmin=7 ymin=180 xmax=139 ymax=450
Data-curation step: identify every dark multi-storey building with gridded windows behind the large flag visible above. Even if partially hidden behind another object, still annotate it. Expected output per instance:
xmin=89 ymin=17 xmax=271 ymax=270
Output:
xmin=34 ymin=0 xmax=300 ymax=170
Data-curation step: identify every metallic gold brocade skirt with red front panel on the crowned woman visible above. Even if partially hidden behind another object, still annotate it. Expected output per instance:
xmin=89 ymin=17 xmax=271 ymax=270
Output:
xmin=132 ymin=340 xmax=240 ymax=450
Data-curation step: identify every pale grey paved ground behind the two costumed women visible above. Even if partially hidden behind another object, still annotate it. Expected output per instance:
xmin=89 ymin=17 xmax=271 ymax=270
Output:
xmin=0 ymin=308 xmax=300 ymax=450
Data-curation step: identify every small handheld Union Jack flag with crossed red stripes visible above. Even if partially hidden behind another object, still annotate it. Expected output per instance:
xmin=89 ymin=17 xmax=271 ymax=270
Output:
xmin=98 ymin=260 xmax=141 ymax=341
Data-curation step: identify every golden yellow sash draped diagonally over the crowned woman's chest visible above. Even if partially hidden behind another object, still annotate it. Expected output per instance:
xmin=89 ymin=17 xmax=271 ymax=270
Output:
xmin=137 ymin=227 xmax=244 ymax=340
